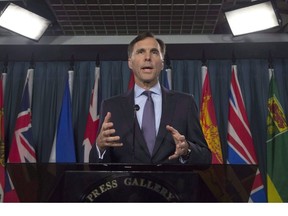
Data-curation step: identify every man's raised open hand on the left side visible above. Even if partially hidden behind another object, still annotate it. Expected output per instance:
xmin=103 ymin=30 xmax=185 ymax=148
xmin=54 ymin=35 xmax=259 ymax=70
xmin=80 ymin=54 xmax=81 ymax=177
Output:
xmin=96 ymin=112 xmax=123 ymax=152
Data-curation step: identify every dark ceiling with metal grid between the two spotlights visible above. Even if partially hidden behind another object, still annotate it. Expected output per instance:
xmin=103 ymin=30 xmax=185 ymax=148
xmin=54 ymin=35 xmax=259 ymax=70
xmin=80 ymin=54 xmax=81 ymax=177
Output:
xmin=0 ymin=0 xmax=288 ymax=36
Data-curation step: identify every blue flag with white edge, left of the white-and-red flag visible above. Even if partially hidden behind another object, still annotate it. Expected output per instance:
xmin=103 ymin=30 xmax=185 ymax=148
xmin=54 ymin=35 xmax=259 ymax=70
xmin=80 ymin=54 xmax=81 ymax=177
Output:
xmin=49 ymin=74 xmax=76 ymax=163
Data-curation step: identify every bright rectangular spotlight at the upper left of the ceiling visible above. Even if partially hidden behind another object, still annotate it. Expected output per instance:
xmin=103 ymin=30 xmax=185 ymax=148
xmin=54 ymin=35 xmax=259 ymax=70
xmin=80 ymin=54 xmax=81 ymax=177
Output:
xmin=0 ymin=3 xmax=51 ymax=41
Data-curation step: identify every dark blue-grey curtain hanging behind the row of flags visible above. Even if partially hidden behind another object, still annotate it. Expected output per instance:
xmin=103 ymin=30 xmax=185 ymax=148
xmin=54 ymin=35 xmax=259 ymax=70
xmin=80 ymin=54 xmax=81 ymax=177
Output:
xmin=0 ymin=59 xmax=288 ymax=182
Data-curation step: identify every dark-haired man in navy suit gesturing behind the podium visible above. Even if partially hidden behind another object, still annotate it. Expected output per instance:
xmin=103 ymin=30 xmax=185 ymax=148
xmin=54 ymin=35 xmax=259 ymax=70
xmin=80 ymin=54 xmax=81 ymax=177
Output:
xmin=90 ymin=32 xmax=211 ymax=164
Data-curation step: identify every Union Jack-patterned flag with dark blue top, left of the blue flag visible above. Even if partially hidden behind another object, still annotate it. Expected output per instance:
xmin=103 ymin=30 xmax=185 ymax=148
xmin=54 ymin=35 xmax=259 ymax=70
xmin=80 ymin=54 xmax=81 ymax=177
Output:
xmin=8 ymin=69 xmax=36 ymax=163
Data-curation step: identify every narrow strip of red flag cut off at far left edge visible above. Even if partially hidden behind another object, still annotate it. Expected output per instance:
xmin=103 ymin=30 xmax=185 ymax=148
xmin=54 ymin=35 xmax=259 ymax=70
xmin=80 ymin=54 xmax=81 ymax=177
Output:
xmin=0 ymin=74 xmax=5 ymax=202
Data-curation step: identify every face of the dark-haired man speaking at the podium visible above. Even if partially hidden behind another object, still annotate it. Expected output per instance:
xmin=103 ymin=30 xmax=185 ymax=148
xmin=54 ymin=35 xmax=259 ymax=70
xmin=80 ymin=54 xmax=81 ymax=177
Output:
xmin=128 ymin=37 xmax=164 ymax=88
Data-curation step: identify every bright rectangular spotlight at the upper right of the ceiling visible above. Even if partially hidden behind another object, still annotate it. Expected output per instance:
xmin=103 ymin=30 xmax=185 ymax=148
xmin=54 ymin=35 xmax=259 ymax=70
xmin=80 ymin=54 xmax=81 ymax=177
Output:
xmin=224 ymin=1 xmax=281 ymax=36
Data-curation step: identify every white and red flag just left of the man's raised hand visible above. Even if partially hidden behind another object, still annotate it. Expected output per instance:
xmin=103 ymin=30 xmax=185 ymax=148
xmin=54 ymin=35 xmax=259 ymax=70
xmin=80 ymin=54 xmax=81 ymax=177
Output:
xmin=83 ymin=67 xmax=101 ymax=163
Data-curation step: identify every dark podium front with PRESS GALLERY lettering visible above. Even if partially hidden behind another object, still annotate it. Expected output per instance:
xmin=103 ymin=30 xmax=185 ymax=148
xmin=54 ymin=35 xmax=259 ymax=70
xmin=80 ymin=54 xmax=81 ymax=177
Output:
xmin=6 ymin=164 xmax=257 ymax=202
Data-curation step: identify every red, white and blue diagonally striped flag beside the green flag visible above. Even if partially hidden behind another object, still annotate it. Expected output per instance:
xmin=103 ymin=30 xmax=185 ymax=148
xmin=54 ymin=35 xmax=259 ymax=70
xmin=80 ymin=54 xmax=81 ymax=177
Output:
xmin=227 ymin=65 xmax=266 ymax=202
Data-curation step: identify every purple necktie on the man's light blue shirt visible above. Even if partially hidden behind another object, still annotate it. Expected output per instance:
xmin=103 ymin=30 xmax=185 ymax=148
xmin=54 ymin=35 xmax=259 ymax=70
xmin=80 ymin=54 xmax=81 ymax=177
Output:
xmin=142 ymin=91 xmax=156 ymax=155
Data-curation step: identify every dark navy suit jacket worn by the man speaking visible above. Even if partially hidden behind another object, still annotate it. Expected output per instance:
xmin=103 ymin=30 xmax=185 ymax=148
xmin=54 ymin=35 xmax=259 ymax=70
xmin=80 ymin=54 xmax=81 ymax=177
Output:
xmin=89 ymin=87 xmax=211 ymax=164
